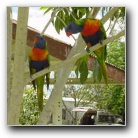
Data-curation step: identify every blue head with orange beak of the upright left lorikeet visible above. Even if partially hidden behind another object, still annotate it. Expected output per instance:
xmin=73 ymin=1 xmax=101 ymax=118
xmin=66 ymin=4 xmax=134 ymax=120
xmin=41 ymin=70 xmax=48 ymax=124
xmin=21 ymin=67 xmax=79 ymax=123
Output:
xmin=34 ymin=34 xmax=46 ymax=49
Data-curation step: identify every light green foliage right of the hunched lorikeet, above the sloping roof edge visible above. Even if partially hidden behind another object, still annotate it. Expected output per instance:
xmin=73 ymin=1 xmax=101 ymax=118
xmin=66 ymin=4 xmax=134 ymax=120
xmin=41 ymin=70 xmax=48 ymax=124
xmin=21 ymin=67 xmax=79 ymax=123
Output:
xmin=106 ymin=41 xmax=125 ymax=70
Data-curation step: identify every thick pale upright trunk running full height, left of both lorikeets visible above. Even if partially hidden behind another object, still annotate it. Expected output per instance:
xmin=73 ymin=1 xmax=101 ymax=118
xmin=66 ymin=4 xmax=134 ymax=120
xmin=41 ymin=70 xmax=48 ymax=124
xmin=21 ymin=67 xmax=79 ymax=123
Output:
xmin=8 ymin=7 xmax=29 ymax=125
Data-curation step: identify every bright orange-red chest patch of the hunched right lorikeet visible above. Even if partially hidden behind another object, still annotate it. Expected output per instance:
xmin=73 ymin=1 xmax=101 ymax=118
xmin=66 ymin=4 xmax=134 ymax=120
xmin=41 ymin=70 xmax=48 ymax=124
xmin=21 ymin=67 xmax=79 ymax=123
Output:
xmin=81 ymin=20 xmax=100 ymax=37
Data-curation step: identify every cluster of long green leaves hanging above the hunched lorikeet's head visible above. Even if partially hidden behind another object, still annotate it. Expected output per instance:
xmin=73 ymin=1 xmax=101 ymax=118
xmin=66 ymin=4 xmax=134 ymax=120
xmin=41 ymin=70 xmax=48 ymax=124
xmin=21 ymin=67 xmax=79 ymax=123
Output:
xmin=40 ymin=7 xmax=91 ymax=33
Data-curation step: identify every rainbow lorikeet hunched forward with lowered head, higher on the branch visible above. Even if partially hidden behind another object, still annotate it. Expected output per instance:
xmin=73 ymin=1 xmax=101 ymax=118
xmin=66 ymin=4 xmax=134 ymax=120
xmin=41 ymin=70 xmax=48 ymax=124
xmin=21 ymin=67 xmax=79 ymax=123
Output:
xmin=65 ymin=18 xmax=107 ymax=83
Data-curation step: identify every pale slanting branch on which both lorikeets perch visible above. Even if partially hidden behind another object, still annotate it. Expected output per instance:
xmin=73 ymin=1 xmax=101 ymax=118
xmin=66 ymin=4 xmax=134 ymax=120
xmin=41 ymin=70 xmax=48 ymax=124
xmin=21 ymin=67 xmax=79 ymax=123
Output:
xmin=25 ymin=30 xmax=125 ymax=84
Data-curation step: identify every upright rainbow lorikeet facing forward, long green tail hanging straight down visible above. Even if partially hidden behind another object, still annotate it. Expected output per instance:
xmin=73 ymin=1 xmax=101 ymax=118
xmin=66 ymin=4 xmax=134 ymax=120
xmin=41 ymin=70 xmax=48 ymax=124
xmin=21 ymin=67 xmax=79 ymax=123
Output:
xmin=29 ymin=35 xmax=50 ymax=111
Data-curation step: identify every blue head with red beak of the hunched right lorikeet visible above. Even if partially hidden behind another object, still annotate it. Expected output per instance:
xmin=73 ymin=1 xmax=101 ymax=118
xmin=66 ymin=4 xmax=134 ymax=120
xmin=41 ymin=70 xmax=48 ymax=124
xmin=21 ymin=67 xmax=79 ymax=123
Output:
xmin=65 ymin=22 xmax=83 ymax=36
